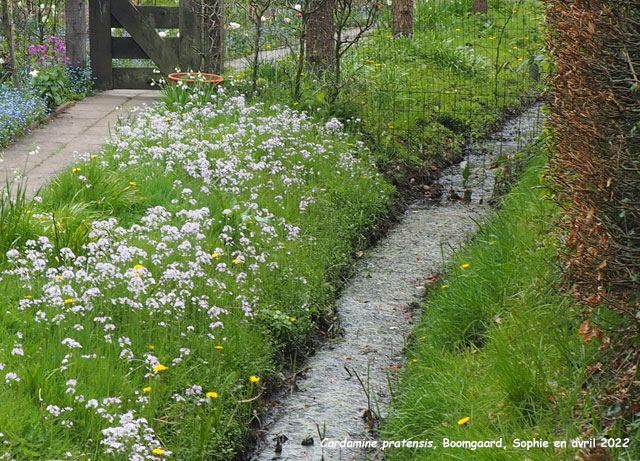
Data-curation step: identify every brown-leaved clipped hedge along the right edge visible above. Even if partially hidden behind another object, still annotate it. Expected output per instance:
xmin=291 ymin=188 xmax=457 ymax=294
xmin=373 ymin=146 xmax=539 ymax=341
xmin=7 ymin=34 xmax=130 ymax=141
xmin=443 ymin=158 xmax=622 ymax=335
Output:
xmin=547 ymin=0 xmax=640 ymax=434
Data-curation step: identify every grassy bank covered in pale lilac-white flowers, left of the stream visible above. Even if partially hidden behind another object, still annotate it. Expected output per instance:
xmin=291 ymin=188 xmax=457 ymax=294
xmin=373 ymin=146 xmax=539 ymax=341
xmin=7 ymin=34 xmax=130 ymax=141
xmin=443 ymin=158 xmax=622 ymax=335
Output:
xmin=0 ymin=89 xmax=392 ymax=460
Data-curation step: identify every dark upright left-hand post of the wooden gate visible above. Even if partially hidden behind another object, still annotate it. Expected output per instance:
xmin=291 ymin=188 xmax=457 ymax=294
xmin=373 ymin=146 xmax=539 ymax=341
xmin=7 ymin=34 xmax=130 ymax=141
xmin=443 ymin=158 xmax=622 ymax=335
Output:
xmin=89 ymin=0 xmax=113 ymax=90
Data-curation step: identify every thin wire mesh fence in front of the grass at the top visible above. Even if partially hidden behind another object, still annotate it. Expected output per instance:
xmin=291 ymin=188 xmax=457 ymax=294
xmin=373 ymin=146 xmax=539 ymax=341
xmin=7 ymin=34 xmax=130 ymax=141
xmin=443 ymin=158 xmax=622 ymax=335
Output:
xmin=353 ymin=0 xmax=547 ymax=165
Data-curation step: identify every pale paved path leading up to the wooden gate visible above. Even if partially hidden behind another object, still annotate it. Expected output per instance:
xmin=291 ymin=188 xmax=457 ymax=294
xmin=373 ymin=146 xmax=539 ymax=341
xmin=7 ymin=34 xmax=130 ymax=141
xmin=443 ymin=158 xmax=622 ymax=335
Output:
xmin=0 ymin=90 xmax=160 ymax=195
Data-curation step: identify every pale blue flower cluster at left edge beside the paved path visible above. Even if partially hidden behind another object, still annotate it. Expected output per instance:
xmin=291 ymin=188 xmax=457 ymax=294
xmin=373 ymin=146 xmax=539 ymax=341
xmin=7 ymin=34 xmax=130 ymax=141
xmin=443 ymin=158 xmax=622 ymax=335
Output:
xmin=0 ymin=85 xmax=46 ymax=147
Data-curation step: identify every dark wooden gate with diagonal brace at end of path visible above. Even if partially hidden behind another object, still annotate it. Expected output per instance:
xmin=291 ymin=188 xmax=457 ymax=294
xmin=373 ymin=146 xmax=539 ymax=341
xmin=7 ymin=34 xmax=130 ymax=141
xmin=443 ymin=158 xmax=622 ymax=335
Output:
xmin=89 ymin=0 xmax=202 ymax=90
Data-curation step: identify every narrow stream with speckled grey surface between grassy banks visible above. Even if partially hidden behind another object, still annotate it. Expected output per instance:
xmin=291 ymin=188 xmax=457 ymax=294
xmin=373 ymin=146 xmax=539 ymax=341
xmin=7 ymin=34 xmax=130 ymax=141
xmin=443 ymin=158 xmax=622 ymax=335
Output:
xmin=250 ymin=104 xmax=543 ymax=461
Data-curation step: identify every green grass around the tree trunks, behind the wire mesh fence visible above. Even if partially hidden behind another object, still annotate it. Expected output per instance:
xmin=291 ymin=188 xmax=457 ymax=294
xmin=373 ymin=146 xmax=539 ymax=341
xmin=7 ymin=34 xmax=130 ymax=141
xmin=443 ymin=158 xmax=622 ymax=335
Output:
xmin=227 ymin=0 xmax=548 ymax=184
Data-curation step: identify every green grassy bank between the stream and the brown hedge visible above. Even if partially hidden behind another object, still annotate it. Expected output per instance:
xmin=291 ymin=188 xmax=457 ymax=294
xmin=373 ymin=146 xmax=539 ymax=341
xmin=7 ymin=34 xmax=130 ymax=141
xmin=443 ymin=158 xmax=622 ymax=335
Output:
xmin=383 ymin=154 xmax=615 ymax=460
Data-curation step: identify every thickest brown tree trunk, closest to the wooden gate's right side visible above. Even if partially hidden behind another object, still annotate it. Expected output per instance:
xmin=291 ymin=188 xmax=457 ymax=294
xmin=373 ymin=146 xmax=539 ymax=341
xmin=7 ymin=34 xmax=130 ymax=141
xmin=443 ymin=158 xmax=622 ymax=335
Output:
xmin=306 ymin=0 xmax=335 ymax=72
